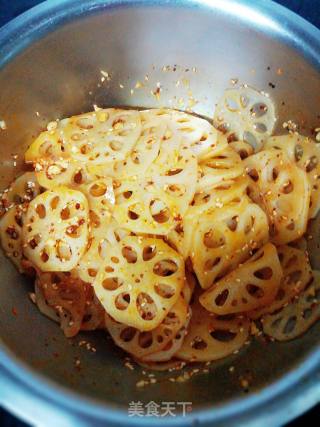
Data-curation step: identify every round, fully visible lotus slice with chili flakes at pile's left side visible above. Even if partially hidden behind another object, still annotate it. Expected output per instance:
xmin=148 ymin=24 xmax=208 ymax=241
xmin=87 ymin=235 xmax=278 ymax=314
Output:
xmin=23 ymin=186 xmax=88 ymax=271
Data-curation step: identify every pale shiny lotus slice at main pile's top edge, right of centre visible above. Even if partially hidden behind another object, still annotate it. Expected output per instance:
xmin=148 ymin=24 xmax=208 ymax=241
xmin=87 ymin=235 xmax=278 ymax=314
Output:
xmin=141 ymin=108 xmax=217 ymax=160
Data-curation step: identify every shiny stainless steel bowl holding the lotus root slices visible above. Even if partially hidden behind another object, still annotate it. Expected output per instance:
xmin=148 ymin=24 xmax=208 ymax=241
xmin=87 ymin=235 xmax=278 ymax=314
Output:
xmin=0 ymin=0 xmax=320 ymax=426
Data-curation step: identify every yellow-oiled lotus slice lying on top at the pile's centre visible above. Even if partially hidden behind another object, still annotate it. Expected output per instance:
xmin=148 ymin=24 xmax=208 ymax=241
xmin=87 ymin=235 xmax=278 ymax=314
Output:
xmin=114 ymin=153 xmax=197 ymax=235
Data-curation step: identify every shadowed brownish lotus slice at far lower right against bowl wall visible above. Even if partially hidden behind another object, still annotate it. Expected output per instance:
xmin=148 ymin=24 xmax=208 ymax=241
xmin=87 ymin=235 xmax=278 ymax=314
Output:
xmin=262 ymin=271 xmax=320 ymax=341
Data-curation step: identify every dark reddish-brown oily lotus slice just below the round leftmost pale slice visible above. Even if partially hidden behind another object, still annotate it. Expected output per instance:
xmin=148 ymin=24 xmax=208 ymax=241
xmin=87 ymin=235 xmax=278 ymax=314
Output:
xmin=36 ymin=272 xmax=92 ymax=337
